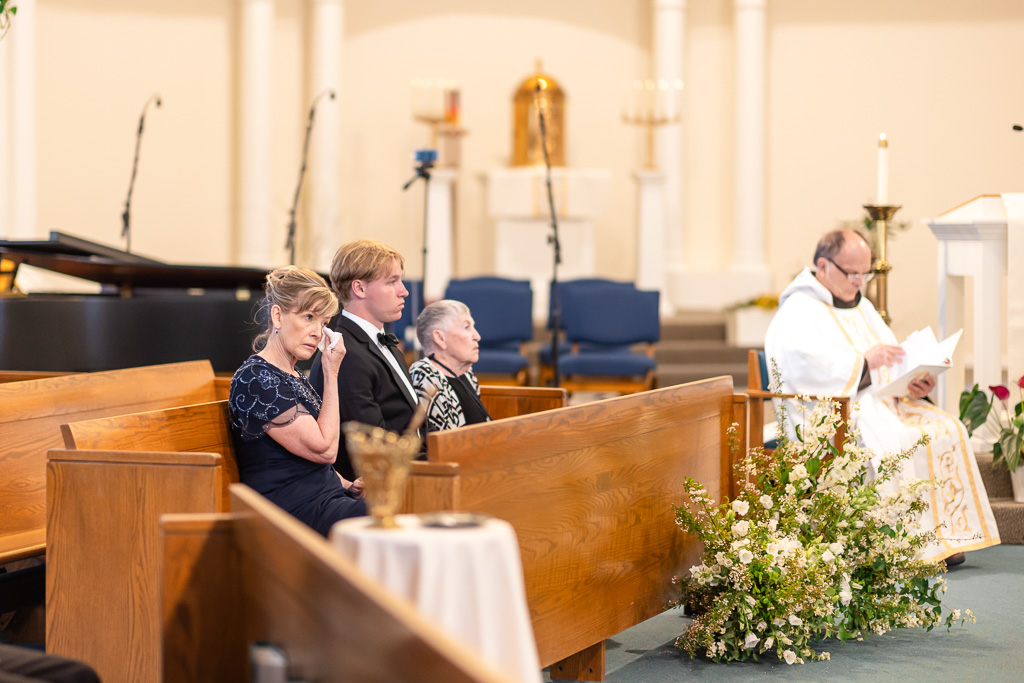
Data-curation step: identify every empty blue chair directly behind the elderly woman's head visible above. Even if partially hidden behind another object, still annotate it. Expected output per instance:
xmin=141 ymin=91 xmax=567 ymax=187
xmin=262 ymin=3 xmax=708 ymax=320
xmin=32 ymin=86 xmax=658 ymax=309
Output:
xmin=444 ymin=276 xmax=534 ymax=386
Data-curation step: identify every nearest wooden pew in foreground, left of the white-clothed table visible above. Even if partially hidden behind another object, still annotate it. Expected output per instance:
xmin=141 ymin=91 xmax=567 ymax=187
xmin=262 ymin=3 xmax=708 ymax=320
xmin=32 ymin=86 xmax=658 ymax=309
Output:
xmin=160 ymin=484 xmax=513 ymax=683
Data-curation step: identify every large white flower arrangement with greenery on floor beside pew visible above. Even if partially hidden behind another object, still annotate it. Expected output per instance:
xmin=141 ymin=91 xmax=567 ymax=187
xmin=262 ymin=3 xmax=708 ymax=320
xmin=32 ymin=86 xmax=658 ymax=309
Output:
xmin=676 ymin=401 xmax=975 ymax=665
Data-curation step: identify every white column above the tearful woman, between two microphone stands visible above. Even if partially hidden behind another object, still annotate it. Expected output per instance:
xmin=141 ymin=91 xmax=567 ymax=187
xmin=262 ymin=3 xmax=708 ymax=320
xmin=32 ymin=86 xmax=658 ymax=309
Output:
xmin=238 ymin=0 xmax=274 ymax=267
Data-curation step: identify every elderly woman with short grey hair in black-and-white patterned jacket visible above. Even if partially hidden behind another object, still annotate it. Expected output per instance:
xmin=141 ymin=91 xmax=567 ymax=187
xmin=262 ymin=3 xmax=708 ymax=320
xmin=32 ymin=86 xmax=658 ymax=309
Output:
xmin=409 ymin=299 xmax=490 ymax=431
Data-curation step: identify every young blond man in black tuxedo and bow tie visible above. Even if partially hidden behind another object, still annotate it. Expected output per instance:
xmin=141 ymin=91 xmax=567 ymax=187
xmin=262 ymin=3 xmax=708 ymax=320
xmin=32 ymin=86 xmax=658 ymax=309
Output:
xmin=309 ymin=240 xmax=417 ymax=479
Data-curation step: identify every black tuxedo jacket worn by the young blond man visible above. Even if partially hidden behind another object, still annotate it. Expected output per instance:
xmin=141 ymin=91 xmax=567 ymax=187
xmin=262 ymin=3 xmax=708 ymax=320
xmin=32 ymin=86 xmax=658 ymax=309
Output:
xmin=309 ymin=315 xmax=416 ymax=479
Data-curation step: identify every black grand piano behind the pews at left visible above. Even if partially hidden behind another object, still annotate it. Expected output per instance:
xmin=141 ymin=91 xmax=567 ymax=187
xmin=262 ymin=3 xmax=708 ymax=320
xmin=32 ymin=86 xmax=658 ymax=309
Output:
xmin=0 ymin=232 xmax=266 ymax=373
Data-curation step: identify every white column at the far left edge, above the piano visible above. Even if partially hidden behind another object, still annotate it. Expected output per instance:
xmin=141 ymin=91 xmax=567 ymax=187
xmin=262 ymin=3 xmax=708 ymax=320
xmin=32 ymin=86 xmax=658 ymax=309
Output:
xmin=4 ymin=0 xmax=39 ymax=239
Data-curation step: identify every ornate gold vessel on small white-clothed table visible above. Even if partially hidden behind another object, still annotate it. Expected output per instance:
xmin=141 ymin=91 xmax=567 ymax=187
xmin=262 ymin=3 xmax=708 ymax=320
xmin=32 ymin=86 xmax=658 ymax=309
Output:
xmin=341 ymin=422 xmax=420 ymax=528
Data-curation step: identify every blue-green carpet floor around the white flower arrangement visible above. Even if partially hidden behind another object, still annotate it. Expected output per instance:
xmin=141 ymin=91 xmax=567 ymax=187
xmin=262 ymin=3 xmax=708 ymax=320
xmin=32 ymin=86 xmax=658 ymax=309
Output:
xmin=546 ymin=546 xmax=1024 ymax=683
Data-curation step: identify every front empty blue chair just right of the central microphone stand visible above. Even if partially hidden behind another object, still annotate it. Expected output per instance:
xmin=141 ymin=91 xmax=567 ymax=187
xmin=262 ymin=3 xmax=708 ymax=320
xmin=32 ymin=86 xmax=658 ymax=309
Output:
xmin=559 ymin=283 xmax=662 ymax=393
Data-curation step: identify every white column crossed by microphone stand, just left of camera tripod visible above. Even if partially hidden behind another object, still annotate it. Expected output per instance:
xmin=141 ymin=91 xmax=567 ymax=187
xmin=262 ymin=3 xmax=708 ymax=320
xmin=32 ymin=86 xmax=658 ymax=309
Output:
xmin=307 ymin=0 xmax=345 ymax=271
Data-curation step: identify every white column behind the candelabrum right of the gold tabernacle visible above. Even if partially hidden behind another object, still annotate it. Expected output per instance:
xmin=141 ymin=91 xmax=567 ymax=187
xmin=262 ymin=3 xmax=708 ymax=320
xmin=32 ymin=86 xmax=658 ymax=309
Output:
xmin=651 ymin=0 xmax=686 ymax=278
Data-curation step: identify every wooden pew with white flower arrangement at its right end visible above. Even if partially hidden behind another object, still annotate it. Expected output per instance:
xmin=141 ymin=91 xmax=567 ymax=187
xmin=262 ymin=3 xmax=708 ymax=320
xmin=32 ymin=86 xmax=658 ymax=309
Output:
xmin=407 ymin=378 xmax=745 ymax=680
